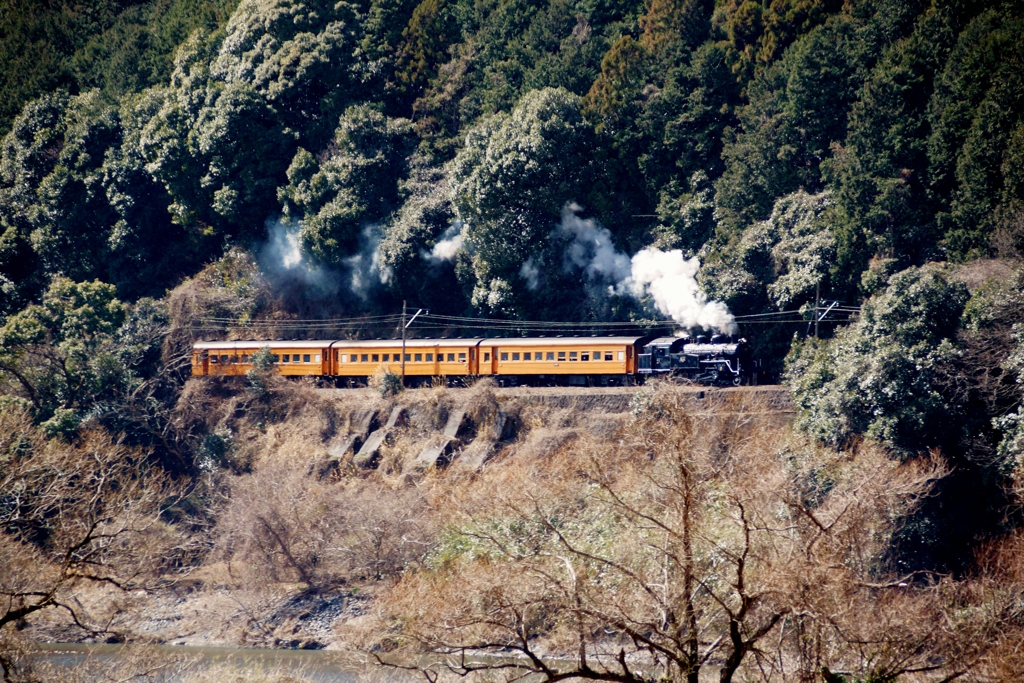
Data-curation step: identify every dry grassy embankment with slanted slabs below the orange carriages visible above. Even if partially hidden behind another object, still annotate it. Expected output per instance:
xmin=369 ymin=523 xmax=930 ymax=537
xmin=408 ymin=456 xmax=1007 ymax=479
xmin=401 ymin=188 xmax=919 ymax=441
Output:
xmin=22 ymin=380 xmax=793 ymax=649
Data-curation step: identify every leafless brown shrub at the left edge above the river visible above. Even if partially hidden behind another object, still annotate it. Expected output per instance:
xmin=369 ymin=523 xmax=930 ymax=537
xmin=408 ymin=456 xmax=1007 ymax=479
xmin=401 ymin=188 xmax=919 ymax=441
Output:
xmin=0 ymin=405 xmax=184 ymax=674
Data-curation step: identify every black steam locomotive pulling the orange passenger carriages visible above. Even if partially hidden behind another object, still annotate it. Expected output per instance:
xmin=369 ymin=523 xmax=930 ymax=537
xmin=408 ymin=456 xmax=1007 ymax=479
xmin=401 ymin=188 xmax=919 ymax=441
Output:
xmin=637 ymin=335 xmax=756 ymax=386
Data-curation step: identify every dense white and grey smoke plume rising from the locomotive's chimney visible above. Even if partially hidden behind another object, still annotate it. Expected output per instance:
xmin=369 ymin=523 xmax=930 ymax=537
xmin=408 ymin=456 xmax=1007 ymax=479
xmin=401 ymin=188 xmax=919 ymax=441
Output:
xmin=552 ymin=204 xmax=737 ymax=334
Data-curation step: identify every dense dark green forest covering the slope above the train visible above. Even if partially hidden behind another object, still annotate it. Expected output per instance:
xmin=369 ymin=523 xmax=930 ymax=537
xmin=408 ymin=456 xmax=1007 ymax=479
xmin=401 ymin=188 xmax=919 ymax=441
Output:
xmin=0 ymin=0 xmax=1024 ymax=331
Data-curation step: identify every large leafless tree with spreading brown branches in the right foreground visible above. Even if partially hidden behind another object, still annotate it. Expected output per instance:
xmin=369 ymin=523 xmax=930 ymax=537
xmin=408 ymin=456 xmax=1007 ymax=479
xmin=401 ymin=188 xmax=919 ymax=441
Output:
xmin=370 ymin=386 xmax=949 ymax=682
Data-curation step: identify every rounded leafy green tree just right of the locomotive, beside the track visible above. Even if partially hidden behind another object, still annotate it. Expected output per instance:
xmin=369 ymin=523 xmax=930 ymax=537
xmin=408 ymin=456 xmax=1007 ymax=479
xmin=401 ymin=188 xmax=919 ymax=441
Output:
xmin=786 ymin=266 xmax=967 ymax=457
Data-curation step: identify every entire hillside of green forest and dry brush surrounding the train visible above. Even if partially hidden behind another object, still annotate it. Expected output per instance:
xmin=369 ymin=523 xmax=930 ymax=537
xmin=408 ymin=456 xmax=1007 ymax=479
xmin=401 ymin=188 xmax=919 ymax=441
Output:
xmin=0 ymin=0 xmax=1024 ymax=683
